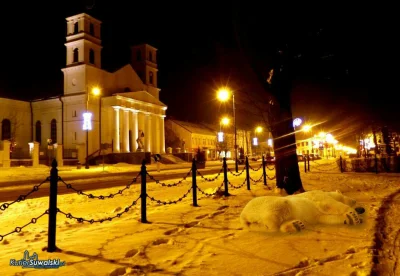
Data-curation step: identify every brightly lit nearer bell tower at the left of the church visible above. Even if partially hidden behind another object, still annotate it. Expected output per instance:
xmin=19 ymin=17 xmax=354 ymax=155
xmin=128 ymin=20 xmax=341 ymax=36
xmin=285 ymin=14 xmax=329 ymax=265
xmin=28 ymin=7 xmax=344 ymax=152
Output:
xmin=62 ymin=13 xmax=102 ymax=95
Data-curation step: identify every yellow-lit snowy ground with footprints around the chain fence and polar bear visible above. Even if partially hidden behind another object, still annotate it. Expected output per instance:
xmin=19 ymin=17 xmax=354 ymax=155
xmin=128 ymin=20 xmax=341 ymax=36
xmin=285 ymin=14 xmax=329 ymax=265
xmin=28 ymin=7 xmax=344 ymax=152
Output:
xmin=0 ymin=160 xmax=400 ymax=276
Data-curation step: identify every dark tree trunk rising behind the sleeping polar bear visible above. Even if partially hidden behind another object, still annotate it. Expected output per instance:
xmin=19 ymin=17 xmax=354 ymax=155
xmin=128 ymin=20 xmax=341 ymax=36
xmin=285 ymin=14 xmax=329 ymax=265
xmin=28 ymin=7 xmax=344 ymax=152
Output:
xmin=233 ymin=1 xmax=304 ymax=194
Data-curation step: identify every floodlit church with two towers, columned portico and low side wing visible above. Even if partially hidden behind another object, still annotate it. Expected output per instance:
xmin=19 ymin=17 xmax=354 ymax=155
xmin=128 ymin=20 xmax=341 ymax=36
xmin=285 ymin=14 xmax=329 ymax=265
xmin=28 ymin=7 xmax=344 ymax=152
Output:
xmin=0 ymin=13 xmax=167 ymax=164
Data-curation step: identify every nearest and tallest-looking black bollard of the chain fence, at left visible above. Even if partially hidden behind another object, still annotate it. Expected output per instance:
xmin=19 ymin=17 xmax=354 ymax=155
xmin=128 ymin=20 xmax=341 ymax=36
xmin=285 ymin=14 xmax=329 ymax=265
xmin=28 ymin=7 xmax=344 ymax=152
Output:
xmin=47 ymin=159 xmax=58 ymax=252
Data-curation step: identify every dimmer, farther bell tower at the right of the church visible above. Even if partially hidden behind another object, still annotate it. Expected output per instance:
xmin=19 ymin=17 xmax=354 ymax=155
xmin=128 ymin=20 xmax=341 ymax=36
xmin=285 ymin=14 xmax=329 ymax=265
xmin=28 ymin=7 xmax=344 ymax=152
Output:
xmin=131 ymin=44 xmax=158 ymax=88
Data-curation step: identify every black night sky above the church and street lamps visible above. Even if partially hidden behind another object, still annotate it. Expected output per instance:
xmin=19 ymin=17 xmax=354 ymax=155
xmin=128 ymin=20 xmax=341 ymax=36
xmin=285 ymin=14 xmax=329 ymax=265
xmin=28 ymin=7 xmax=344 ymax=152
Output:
xmin=0 ymin=0 xmax=400 ymax=144
